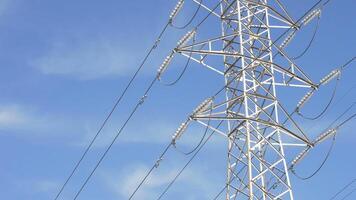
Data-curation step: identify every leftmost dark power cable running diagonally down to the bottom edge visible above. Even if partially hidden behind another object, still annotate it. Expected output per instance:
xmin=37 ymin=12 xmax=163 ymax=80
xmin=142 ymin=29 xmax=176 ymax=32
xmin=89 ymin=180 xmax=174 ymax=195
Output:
xmin=54 ymin=21 xmax=170 ymax=200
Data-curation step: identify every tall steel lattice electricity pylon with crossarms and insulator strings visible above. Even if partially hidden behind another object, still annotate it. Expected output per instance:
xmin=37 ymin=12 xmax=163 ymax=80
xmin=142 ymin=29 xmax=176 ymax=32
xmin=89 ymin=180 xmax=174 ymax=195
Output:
xmin=159 ymin=0 xmax=336 ymax=200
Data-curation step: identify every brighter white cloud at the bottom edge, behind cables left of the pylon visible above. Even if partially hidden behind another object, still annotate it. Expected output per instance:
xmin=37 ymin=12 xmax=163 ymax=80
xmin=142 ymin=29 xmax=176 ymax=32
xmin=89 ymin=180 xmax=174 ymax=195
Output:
xmin=102 ymin=163 xmax=217 ymax=199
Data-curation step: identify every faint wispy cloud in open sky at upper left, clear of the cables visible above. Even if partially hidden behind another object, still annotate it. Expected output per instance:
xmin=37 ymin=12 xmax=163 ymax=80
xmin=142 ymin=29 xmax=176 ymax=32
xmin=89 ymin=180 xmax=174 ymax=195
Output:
xmin=31 ymin=38 xmax=133 ymax=80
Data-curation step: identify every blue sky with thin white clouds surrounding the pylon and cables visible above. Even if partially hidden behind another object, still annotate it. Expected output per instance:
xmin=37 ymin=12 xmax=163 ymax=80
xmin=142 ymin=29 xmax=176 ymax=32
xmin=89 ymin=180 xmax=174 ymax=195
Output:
xmin=0 ymin=0 xmax=356 ymax=200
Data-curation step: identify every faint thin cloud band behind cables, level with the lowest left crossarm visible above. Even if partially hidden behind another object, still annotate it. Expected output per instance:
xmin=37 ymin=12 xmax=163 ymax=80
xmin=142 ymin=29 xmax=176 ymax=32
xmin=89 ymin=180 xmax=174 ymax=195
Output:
xmin=74 ymin=119 xmax=225 ymax=149
